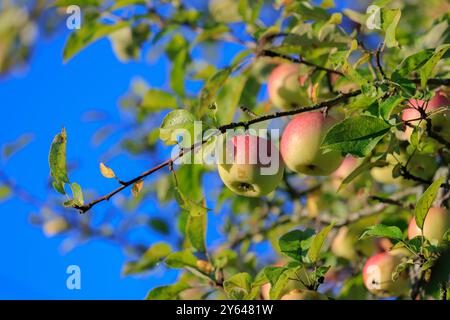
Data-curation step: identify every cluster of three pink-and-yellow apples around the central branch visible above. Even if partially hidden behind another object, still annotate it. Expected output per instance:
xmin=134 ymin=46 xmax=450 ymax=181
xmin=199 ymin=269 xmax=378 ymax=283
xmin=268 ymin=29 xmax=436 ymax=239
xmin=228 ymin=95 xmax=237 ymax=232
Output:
xmin=218 ymin=64 xmax=343 ymax=197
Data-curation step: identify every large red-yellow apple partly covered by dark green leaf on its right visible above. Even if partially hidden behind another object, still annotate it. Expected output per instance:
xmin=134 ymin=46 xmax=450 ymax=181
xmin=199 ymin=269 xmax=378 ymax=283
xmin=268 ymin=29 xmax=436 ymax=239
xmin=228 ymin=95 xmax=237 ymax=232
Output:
xmin=280 ymin=112 xmax=343 ymax=176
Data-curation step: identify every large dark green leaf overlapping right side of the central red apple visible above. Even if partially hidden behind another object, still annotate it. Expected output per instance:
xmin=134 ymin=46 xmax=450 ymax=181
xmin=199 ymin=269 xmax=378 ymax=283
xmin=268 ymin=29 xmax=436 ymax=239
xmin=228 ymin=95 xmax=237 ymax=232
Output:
xmin=322 ymin=115 xmax=391 ymax=157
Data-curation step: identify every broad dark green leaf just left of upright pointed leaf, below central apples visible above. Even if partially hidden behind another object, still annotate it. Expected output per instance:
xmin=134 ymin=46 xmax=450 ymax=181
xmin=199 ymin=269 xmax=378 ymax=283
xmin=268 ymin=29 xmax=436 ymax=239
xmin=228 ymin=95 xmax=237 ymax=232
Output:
xmin=278 ymin=229 xmax=314 ymax=261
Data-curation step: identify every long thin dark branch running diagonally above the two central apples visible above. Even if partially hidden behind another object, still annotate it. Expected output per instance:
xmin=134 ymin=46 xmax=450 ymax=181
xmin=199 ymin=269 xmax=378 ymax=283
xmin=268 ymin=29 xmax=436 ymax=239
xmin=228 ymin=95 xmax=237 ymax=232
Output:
xmin=74 ymin=90 xmax=361 ymax=213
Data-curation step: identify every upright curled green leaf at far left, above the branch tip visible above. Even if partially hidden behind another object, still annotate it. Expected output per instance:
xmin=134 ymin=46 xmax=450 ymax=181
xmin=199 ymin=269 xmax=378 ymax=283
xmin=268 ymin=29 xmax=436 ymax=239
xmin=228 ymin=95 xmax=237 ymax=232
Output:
xmin=48 ymin=128 xmax=69 ymax=194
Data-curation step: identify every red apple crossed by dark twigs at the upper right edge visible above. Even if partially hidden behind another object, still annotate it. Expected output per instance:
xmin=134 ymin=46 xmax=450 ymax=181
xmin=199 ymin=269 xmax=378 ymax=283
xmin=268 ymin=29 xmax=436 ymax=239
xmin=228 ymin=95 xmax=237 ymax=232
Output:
xmin=402 ymin=91 xmax=450 ymax=141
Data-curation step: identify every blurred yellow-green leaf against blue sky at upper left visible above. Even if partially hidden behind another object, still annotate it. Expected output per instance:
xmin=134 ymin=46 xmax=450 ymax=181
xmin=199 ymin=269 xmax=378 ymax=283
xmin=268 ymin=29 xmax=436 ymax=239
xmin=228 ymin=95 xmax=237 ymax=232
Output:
xmin=63 ymin=21 xmax=129 ymax=62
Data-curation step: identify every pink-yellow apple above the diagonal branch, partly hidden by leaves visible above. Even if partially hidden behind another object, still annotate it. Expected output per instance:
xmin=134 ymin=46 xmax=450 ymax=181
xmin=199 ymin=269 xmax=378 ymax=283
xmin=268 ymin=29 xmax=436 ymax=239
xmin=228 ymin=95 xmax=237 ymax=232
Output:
xmin=267 ymin=63 xmax=309 ymax=109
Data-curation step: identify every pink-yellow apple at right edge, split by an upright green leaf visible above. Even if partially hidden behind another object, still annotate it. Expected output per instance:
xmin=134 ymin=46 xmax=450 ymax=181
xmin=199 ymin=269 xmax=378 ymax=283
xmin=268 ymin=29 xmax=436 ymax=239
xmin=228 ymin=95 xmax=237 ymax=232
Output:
xmin=408 ymin=207 xmax=450 ymax=242
